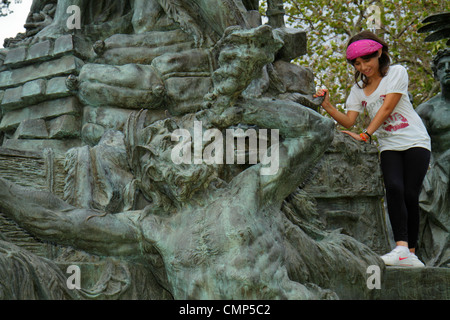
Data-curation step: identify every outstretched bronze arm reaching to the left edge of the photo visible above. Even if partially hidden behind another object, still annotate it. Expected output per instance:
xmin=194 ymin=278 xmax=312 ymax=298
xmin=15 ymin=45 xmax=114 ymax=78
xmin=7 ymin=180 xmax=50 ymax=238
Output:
xmin=0 ymin=178 xmax=139 ymax=255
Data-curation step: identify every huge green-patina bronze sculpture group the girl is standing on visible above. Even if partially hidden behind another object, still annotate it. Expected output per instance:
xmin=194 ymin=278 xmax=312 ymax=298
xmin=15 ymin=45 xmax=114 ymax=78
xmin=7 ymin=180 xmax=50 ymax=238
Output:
xmin=0 ymin=0 xmax=449 ymax=299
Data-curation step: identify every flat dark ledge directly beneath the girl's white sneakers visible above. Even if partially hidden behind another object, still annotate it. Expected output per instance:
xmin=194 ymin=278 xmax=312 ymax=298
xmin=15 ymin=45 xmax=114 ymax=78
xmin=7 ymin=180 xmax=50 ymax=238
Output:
xmin=380 ymin=267 xmax=450 ymax=300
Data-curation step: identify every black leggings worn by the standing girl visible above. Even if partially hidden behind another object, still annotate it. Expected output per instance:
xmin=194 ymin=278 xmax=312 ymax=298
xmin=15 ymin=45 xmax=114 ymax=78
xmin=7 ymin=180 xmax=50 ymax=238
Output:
xmin=380 ymin=148 xmax=431 ymax=248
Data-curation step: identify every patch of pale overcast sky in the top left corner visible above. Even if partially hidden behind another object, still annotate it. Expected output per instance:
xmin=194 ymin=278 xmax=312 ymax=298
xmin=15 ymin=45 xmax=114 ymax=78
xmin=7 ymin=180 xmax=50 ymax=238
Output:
xmin=0 ymin=0 xmax=33 ymax=48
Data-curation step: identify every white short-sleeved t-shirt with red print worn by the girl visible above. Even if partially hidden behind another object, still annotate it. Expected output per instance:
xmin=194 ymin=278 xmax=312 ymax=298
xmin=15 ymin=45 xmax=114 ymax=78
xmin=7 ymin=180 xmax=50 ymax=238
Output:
xmin=346 ymin=65 xmax=431 ymax=151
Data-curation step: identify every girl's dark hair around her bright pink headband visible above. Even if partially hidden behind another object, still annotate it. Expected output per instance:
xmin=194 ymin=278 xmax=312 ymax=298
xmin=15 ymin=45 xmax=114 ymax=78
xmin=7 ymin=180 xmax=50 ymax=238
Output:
xmin=347 ymin=31 xmax=391 ymax=88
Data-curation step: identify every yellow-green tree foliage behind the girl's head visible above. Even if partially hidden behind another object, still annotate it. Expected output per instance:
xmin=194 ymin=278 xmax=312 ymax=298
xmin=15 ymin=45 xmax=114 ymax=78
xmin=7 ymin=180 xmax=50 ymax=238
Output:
xmin=261 ymin=0 xmax=450 ymax=130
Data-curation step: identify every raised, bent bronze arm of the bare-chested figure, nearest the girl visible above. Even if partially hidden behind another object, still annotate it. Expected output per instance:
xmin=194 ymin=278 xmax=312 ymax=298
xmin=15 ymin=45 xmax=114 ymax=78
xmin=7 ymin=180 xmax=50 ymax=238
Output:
xmin=243 ymin=100 xmax=334 ymax=201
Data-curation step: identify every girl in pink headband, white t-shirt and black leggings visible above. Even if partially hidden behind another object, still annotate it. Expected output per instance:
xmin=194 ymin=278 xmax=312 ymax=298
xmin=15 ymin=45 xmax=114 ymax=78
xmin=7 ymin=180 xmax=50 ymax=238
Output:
xmin=316 ymin=31 xmax=431 ymax=267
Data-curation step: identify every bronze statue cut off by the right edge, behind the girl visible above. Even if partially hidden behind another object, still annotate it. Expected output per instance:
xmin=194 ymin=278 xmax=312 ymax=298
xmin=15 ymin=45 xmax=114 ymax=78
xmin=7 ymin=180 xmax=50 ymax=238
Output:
xmin=417 ymin=48 xmax=450 ymax=266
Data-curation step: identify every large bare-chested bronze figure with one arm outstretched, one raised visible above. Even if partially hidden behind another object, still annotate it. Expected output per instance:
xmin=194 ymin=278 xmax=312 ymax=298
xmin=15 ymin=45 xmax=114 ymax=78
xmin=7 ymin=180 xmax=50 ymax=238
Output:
xmin=0 ymin=91 xmax=342 ymax=299
